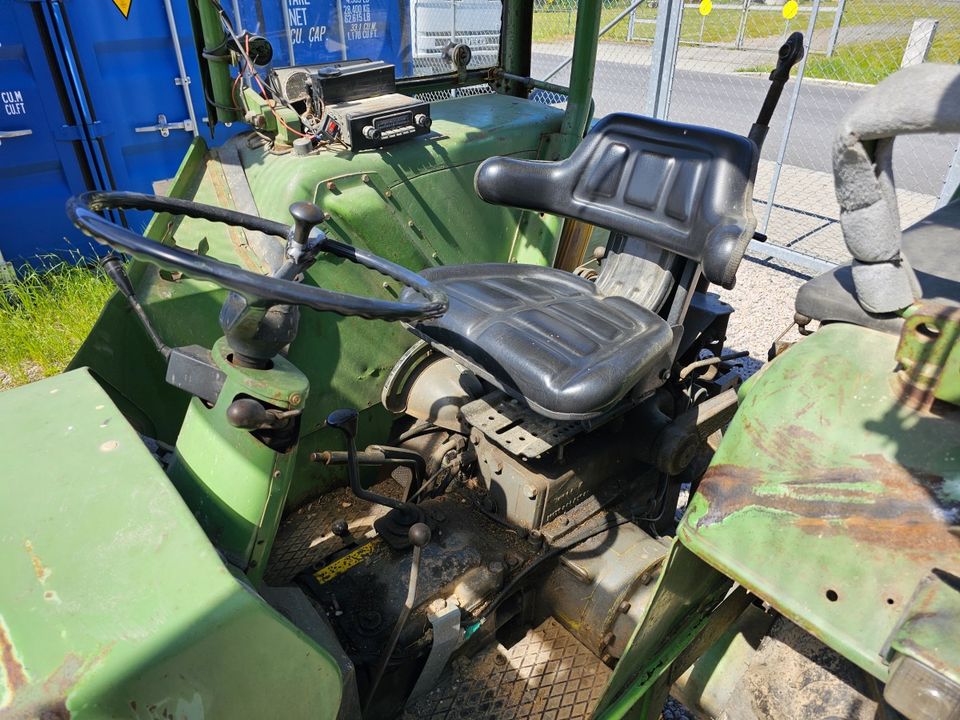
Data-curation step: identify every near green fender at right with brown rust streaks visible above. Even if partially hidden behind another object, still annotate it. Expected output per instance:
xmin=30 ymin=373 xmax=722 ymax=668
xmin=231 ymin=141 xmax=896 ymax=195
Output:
xmin=679 ymin=324 xmax=960 ymax=680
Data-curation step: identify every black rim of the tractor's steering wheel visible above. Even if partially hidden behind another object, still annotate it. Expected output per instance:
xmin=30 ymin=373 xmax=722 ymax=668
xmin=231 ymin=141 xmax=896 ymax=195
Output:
xmin=66 ymin=191 xmax=448 ymax=321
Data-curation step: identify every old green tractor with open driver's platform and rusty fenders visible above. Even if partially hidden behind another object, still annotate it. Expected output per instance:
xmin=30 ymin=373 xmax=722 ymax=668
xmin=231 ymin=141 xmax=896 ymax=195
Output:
xmin=0 ymin=0 xmax=960 ymax=720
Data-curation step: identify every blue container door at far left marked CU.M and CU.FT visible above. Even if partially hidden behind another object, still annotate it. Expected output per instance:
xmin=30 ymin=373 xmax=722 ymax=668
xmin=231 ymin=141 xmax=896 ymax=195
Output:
xmin=0 ymin=0 xmax=96 ymax=265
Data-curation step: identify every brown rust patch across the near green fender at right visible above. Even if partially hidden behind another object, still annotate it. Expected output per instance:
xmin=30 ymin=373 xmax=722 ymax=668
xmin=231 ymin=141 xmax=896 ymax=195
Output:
xmin=696 ymin=455 xmax=960 ymax=566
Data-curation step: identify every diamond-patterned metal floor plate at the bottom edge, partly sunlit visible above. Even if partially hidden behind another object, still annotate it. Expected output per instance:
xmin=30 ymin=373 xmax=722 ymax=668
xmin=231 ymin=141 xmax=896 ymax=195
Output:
xmin=404 ymin=618 xmax=611 ymax=720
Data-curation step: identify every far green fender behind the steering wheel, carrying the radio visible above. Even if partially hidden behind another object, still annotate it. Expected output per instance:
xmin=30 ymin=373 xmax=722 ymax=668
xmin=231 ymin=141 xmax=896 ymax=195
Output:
xmin=74 ymin=95 xmax=562 ymax=505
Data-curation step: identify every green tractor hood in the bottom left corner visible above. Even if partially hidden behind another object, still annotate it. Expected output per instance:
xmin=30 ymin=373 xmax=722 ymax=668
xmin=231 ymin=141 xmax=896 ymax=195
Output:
xmin=0 ymin=369 xmax=340 ymax=720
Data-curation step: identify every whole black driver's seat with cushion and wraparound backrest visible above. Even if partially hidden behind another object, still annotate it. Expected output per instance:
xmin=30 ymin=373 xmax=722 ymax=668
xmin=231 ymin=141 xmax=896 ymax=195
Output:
xmin=400 ymin=114 xmax=757 ymax=420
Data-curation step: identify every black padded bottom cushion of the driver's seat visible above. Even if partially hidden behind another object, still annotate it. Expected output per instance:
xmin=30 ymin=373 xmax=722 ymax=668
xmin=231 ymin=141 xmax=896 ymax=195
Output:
xmin=405 ymin=263 xmax=673 ymax=420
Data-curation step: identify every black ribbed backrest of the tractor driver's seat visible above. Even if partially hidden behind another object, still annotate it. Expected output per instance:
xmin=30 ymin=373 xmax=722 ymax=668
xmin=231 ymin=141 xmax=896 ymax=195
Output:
xmin=474 ymin=113 xmax=758 ymax=288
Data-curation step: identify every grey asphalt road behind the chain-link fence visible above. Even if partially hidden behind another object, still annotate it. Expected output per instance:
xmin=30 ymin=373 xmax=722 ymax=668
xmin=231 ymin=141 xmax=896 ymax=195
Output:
xmin=532 ymin=53 xmax=957 ymax=195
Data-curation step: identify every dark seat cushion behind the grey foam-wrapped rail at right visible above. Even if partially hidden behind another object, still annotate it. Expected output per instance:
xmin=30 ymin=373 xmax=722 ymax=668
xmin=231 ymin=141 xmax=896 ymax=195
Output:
xmin=796 ymin=202 xmax=960 ymax=332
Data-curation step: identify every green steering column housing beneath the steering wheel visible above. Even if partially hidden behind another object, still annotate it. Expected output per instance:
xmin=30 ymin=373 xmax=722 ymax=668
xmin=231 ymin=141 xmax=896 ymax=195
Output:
xmin=169 ymin=339 xmax=309 ymax=584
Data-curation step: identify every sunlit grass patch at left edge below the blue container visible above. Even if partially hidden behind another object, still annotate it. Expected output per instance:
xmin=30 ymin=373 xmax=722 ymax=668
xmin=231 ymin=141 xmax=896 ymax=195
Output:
xmin=0 ymin=260 xmax=113 ymax=389
